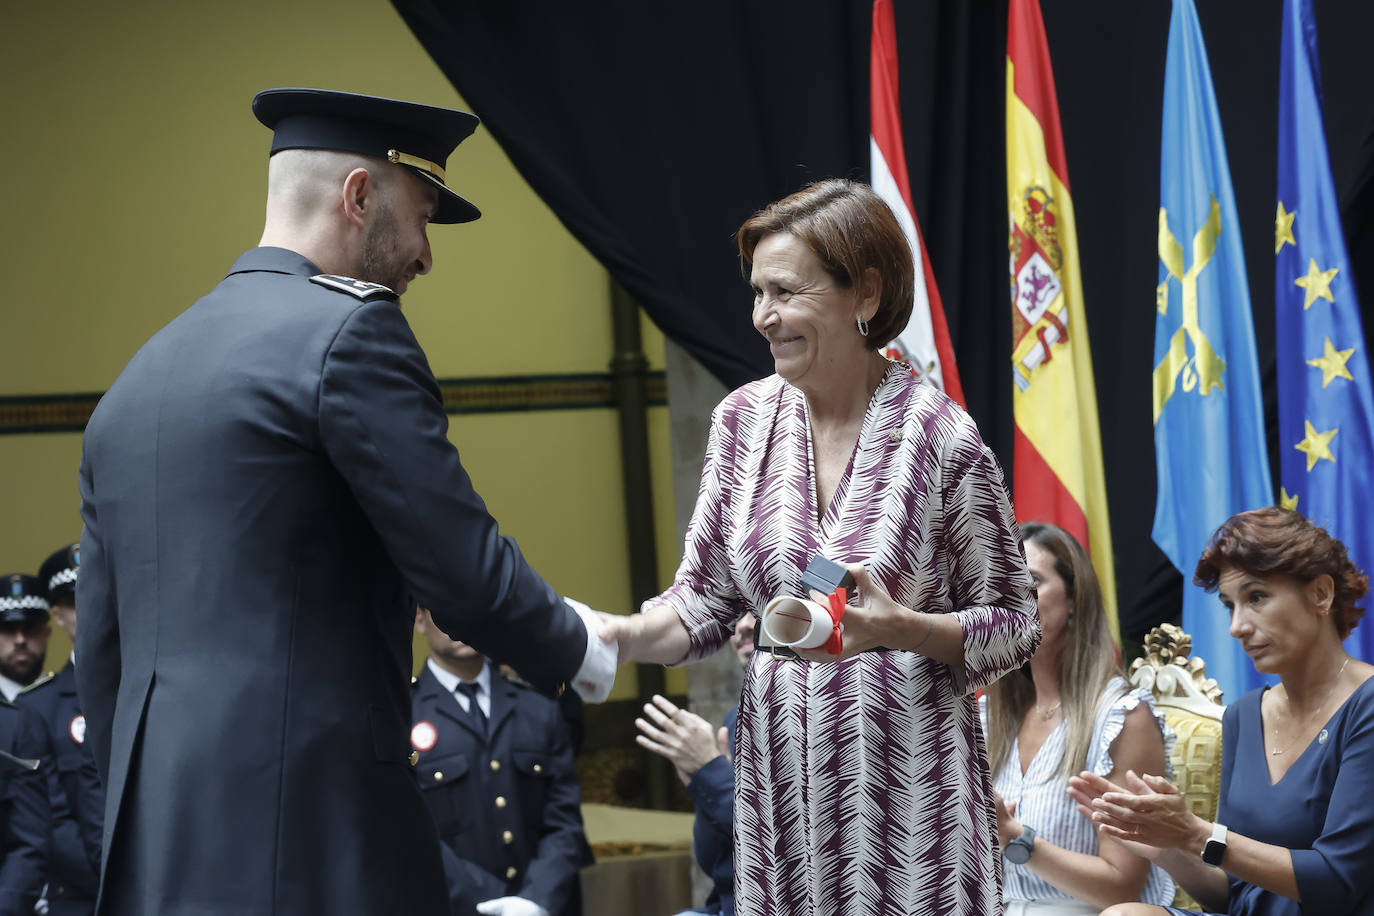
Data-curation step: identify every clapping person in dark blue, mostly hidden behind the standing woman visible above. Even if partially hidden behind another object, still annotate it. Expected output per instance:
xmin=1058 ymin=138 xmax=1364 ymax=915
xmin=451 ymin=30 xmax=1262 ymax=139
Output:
xmin=635 ymin=614 xmax=756 ymax=916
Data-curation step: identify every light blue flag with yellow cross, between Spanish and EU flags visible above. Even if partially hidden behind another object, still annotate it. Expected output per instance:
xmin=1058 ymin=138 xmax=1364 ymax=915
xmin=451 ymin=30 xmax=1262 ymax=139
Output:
xmin=1154 ymin=0 xmax=1274 ymax=700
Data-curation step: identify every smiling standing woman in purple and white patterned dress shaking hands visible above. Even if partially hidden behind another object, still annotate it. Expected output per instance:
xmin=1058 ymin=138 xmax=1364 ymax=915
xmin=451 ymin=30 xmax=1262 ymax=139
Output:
xmin=603 ymin=180 xmax=1040 ymax=916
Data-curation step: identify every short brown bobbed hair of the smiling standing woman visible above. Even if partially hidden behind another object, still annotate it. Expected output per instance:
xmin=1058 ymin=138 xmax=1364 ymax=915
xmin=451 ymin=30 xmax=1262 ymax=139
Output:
xmin=736 ymin=179 xmax=916 ymax=350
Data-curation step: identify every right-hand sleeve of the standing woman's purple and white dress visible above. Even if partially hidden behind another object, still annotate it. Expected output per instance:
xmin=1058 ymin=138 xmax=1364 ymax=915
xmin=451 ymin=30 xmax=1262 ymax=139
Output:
xmin=941 ymin=423 xmax=1040 ymax=694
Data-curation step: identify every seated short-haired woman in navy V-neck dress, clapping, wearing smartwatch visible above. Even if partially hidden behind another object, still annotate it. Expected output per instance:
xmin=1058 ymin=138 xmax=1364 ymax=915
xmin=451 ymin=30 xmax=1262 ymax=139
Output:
xmin=1070 ymin=508 xmax=1374 ymax=916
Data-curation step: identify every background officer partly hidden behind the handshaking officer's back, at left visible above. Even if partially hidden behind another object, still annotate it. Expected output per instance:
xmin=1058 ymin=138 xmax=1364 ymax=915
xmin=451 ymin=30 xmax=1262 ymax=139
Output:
xmin=15 ymin=544 xmax=104 ymax=916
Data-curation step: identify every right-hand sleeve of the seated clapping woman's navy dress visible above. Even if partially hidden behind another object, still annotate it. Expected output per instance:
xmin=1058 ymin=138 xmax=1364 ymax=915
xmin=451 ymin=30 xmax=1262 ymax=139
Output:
xmin=1292 ymin=688 xmax=1374 ymax=916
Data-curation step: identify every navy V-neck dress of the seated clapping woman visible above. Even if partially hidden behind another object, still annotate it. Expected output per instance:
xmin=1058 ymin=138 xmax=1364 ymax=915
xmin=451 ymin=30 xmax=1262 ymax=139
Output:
xmin=1172 ymin=677 xmax=1374 ymax=916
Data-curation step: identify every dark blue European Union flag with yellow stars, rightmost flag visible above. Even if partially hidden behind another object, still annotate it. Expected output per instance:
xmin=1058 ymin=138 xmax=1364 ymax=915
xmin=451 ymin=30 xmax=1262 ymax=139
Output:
xmin=1274 ymin=0 xmax=1374 ymax=661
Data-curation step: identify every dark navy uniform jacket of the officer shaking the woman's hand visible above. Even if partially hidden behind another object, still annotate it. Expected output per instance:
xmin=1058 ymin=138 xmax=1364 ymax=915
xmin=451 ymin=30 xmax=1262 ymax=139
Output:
xmin=76 ymin=249 xmax=587 ymax=916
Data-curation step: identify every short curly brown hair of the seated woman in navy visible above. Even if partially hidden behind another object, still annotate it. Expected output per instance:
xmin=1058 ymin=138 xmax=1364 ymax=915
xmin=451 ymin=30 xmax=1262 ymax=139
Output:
xmin=1193 ymin=505 xmax=1370 ymax=640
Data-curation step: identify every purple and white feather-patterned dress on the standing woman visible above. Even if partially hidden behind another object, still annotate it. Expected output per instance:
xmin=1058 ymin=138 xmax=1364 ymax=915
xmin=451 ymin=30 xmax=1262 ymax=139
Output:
xmin=646 ymin=364 xmax=1040 ymax=916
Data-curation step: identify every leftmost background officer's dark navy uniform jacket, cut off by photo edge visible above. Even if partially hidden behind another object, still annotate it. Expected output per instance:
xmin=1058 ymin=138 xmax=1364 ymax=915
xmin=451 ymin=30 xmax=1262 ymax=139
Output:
xmin=0 ymin=699 xmax=51 ymax=916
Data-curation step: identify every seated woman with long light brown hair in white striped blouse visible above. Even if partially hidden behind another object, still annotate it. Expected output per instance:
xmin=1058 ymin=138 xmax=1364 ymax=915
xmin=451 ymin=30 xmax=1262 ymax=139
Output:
xmin=984 ymin=522 xmax=1173 ymax=916
